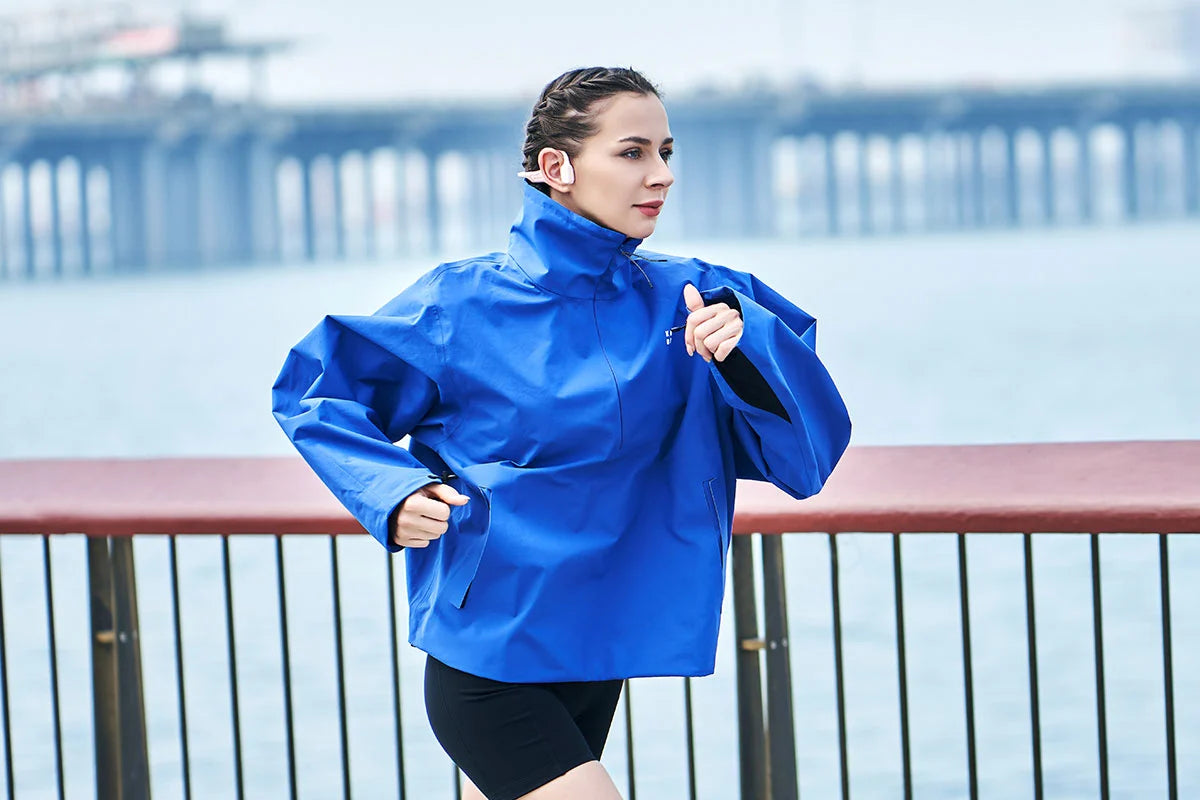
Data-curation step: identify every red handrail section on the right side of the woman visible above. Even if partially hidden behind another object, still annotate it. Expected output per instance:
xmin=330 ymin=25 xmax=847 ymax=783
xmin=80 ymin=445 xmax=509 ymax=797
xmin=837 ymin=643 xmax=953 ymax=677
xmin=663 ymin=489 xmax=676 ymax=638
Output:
xmin=736 ymin=440 xmax=1200 ymax=534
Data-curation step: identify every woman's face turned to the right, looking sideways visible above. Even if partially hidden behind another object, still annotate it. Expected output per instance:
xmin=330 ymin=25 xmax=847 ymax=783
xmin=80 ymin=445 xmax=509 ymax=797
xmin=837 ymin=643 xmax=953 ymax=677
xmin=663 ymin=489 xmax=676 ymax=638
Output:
xmin=547 ymin=92 xmax=674 ymax=239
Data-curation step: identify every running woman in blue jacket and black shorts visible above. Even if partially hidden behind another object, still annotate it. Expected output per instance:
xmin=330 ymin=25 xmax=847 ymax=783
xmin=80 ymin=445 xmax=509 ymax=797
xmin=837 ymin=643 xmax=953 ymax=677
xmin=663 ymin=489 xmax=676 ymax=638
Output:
xmin=274 ymin=68 xmax=850 ymax=800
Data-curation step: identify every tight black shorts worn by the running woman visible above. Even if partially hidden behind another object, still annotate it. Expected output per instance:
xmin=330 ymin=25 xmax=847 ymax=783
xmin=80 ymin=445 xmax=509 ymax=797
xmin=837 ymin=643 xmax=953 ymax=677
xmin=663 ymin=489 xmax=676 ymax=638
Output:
xmin=425 ymin=655 xmax=624 ymax=800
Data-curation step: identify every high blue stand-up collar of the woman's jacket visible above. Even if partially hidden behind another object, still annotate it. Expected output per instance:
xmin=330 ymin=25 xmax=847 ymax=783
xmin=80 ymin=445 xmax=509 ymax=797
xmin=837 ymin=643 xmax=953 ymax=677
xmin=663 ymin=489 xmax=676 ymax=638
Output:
xmin=509 ymin=182 xmax=642 ymax=300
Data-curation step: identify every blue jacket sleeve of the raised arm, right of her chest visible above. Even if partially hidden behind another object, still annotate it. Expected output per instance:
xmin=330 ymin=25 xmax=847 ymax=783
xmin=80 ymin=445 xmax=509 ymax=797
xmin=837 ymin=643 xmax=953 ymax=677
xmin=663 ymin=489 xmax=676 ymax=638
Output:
xmin=701 ymin=270 xmax=851 ymax=498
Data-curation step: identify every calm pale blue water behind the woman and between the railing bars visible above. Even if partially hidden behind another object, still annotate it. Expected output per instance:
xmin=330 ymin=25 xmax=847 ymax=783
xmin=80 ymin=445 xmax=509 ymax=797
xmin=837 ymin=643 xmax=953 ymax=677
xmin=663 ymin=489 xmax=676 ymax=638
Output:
xmin=0 ymin=225 xmax=1200 ymax=800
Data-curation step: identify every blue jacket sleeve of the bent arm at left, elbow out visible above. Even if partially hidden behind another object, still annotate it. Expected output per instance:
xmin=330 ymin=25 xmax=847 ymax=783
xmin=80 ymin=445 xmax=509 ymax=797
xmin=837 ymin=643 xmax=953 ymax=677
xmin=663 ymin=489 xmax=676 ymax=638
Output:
xmin=271 ymin=278 xmax=440 ymax=553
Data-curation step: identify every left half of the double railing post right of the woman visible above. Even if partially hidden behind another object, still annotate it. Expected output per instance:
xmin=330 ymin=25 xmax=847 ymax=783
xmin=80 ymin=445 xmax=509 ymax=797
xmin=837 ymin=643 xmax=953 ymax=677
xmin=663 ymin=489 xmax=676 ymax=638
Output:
xmin=732 ymin=535 xmax=769 ymax=800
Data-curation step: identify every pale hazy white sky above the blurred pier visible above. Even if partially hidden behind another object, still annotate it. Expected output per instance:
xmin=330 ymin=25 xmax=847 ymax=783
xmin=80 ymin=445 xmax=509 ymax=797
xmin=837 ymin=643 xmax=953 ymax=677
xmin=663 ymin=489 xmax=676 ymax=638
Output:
xmin=4 ymin=0 xmax=1200 ymax=103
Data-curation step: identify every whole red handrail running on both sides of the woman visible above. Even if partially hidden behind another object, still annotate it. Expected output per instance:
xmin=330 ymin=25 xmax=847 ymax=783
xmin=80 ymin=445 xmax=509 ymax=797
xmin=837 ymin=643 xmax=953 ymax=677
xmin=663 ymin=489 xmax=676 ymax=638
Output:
xmin=0 ymin=440 xmax=1200 ymax=536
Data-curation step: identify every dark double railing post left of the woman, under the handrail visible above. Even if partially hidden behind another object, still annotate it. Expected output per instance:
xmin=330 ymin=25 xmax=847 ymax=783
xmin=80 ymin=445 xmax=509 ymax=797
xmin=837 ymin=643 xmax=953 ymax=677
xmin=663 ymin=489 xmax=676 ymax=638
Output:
xmin=88 ymin=536 xmax=150 ymax=800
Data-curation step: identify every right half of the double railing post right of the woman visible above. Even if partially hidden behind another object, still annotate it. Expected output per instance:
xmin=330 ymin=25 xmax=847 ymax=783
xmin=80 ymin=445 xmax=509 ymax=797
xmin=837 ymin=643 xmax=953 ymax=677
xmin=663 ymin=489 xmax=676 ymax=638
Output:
xmin=761 ymin=535 xmax=800 ymax=800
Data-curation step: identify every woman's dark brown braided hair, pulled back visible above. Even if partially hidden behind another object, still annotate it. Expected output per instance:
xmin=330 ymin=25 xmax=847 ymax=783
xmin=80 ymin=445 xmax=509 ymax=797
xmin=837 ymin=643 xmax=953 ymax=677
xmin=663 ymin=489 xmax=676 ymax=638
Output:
xmin=522 ymin=67 xmax=659 ymax=194
